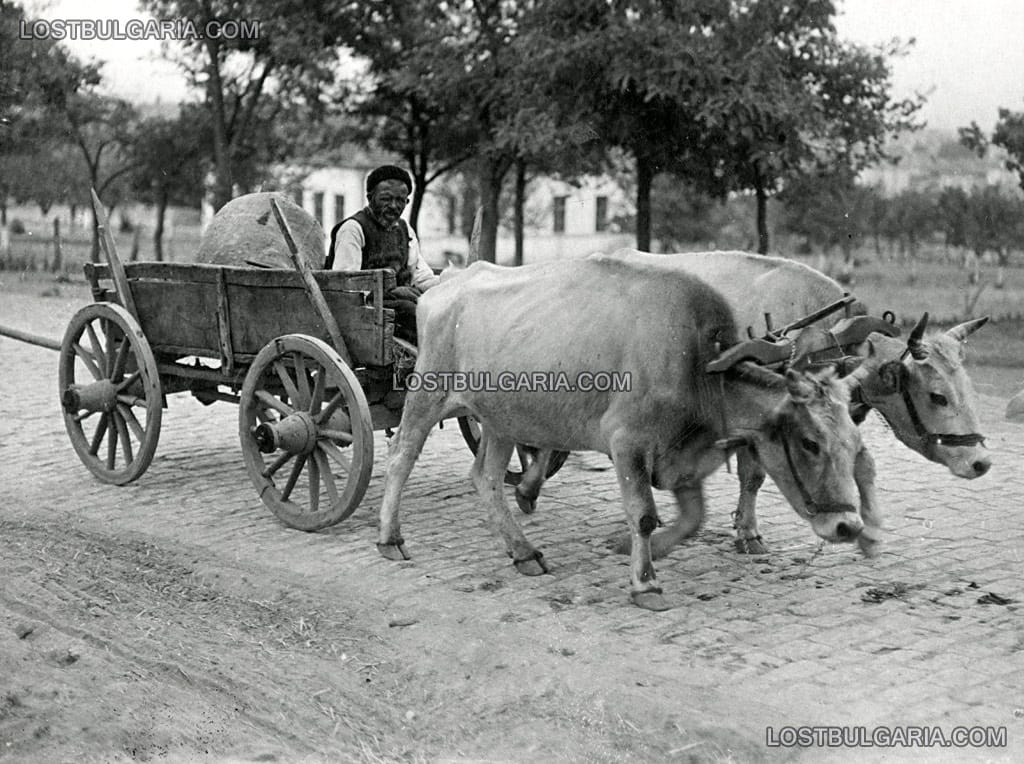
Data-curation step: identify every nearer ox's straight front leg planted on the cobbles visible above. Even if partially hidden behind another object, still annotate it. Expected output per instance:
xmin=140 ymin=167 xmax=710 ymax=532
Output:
xmin=611 ymin=443 xmax=669 ymax=610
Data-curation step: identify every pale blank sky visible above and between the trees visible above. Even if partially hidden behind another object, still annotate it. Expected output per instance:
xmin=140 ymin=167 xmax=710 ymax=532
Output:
xmin=25 ymin=0 xmax=1024 ymax=130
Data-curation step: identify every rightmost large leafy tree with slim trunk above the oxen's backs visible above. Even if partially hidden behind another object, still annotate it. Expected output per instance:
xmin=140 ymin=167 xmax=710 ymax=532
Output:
xmin=706 ymin=0 xmax=923 ymax=253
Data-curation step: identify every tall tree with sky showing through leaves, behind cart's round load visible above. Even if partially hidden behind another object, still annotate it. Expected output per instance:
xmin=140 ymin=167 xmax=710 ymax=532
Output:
xmin=143 ymin=0 xmax=352 ymax=209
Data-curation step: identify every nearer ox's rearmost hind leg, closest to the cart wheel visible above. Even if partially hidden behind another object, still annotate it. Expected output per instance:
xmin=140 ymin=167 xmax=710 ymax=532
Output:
xmin=377 ymin=390 xmax=443 ymax=560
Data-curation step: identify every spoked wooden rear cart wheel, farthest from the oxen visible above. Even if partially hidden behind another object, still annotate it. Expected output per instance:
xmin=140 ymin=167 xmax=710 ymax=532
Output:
xmin=57 ymin=302 xmax=163 ymax=485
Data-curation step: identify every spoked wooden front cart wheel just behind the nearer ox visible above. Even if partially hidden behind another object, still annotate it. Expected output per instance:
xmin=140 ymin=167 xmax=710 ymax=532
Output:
xmin=239 ymin=334 xmax=374 ymax=530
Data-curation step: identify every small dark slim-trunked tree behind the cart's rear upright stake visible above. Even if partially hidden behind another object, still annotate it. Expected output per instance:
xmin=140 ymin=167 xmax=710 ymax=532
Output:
xmin=132 ymin=104 xmax=210 ymax=261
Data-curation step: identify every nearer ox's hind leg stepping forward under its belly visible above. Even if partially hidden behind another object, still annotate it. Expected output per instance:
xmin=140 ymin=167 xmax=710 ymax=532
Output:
xmin=470 ymin=427 xmax=548 ymax=576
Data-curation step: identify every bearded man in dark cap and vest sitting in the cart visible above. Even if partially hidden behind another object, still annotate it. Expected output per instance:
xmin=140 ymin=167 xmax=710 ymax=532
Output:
xmin=324 ymin=165 xmax=438 ymax=345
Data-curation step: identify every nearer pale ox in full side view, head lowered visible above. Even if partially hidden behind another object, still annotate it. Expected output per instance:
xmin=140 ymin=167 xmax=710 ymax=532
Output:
xmin=378 ymin=257 xmax=863 ymax=609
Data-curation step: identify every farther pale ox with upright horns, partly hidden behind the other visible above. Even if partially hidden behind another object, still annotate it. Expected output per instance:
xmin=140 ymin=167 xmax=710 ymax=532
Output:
xmin=516 ymin=249 xmax=991 ymax=557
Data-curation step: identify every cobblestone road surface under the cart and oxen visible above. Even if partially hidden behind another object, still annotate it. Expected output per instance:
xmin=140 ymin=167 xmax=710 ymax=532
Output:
xmin=6 ymin=286 xmax=1024 ymax=761
